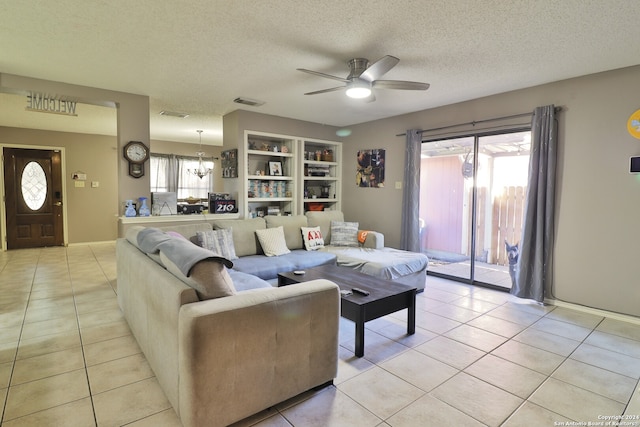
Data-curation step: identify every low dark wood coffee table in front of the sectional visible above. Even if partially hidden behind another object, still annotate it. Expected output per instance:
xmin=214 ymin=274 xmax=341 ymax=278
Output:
xmin=278 ymin=265 xmax=416 ymax=357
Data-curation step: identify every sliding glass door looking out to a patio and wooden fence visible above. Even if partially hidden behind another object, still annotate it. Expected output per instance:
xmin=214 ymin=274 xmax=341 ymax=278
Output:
xmin=420 ymin=130 xmax=531 ymax=288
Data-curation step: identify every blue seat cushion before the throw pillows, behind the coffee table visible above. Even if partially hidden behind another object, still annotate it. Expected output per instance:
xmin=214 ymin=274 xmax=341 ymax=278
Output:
xmin=233 ymin=249 xmax=337 ymax=280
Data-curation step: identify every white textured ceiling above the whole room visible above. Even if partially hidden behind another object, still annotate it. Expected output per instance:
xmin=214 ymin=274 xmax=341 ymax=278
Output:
xmin=0 ymin=0 xmax=640 ymax=144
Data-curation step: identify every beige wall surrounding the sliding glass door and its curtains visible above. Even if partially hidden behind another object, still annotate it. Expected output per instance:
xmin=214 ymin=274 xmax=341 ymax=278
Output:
xmin=343 ymin=67 xmax=640 ymax=316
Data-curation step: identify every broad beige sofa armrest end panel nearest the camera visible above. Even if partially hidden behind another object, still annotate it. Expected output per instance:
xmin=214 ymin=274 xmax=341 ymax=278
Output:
xmin=179 ymin=280 xmax=340 ymax=427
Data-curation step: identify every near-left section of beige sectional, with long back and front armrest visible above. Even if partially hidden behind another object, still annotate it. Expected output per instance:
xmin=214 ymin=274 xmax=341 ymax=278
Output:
xmin=116 ymin=229 xmax=340 ymax=427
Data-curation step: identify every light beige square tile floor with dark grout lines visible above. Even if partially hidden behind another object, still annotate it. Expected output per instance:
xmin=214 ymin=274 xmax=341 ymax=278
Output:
xmin=0 ymin=243 xmax=640 ymax=427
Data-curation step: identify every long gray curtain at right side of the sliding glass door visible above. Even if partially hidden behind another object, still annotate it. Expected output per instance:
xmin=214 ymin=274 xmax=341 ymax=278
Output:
xmin=511 ymin=105 xmax=558 ymax=302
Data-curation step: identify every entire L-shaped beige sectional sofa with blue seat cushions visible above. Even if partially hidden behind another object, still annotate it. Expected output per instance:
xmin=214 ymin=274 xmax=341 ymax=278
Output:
xmin=116 ymin=211 xmax=427 ymax=427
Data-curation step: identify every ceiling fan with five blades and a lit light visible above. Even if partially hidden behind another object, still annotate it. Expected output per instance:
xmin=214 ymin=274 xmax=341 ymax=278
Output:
xmin=297 ymin=55 xmax=429 ymax=102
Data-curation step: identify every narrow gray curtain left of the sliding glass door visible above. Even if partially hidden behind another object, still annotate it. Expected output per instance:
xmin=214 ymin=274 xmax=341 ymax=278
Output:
xmin=400 ymin=129 xmax=422 ymax=252
